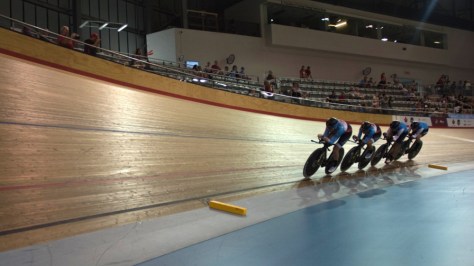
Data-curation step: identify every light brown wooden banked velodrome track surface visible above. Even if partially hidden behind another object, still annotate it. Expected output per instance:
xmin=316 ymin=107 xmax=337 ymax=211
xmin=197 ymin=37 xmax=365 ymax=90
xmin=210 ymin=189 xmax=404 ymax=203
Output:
xmin=0 ymin=55 xmax=474 ymax=250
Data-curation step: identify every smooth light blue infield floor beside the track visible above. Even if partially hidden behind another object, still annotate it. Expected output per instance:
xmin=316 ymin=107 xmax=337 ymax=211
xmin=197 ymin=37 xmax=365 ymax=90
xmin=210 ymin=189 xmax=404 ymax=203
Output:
xmin=139 ymin=171 xmax=474 ymax=266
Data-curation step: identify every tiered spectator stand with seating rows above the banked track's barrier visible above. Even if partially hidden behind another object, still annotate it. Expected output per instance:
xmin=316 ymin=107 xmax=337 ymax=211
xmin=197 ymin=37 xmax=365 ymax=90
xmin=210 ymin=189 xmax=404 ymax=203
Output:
xmin=0 ymin=15 xmax=472 ymax=116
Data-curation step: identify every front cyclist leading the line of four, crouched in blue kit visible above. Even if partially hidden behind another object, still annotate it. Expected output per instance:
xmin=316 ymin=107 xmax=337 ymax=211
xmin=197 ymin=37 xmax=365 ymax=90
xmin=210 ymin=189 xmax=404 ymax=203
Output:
xmin=318 ymin=117 xmax=352 ymax=171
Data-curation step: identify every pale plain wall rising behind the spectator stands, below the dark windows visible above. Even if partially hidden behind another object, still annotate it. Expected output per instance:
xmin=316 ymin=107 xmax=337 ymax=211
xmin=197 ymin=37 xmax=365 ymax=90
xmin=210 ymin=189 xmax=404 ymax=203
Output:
xmin=148 ymin=0 xmax=474 ymax=84
